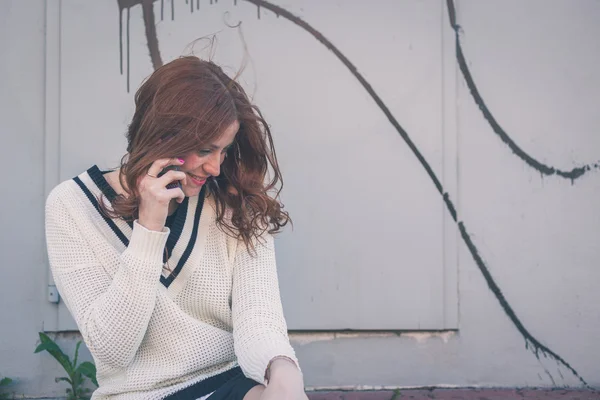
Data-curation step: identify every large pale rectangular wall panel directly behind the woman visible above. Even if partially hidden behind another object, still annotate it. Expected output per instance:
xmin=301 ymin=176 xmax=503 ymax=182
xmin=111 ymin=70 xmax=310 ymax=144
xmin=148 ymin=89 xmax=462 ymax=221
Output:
xmin=54 ymin=0 xmax=458 ymax=330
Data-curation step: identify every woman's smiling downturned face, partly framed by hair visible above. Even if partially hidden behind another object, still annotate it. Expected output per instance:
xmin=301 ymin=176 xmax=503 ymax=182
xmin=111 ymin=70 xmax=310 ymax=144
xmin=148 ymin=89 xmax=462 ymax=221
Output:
xmin=176 ymin=121 xmax=240 ymax=197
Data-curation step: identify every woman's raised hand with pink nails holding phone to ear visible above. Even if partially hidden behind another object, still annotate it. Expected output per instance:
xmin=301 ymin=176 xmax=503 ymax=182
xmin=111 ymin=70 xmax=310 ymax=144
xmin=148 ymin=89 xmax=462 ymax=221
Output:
xmin=138 ymin=158 xmax=185 ymax=231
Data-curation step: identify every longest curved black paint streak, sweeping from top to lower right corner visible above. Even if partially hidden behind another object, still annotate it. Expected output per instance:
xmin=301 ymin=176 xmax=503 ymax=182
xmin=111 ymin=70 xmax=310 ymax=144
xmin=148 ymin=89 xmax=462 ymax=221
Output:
xmin=239 ymin=0 xmax=588 ymax=386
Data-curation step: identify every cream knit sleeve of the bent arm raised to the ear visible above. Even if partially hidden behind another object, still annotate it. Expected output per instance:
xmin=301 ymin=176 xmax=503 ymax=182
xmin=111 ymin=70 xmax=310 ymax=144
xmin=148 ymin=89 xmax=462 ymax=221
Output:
xmin=46 ymin=189 xmax=169 ymax=368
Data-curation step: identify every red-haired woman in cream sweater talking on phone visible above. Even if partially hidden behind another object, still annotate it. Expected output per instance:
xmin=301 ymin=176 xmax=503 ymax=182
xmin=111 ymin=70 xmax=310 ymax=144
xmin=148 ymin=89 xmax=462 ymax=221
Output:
xmin=46 ymin=57 xmax=306 ymax=400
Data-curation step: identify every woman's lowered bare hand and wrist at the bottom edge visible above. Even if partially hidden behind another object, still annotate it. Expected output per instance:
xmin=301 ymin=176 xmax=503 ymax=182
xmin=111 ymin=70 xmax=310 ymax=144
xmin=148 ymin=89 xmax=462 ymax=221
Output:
xmin=260 ymin=359 xmax=308 ymax=400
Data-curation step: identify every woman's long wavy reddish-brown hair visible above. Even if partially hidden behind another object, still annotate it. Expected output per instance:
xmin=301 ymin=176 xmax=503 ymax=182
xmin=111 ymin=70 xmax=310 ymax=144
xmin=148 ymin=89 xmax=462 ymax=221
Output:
xmin=100 ymin=56 xmax=290 ymax=249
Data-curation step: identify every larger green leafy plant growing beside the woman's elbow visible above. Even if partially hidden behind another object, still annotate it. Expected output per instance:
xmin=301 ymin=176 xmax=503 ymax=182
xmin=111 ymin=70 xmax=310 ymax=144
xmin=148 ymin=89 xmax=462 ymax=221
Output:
xmin=35 ymin=332 xmax=98 ymax=400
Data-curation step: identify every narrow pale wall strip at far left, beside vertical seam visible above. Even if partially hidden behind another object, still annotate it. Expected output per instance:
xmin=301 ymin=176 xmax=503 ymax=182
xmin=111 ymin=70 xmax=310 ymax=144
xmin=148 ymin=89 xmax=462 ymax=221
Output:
xmin=0 ymin=0 xmax=94 ymax=396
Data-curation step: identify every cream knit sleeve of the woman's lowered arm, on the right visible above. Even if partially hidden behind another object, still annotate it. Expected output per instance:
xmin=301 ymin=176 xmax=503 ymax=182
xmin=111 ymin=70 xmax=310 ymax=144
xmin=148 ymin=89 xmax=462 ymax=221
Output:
xmin=232 ymin=235 xmax=298 ymax=383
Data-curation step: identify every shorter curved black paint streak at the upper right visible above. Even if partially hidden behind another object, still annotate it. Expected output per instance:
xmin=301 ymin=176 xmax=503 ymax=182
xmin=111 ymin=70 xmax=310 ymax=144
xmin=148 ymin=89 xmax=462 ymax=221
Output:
xmin=446 ymin=0 xmax=600 ymax=182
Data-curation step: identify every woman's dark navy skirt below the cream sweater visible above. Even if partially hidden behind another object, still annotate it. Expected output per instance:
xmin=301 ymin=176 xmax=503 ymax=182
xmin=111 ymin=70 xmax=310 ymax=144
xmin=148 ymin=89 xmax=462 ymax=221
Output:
xmin=165 ymin=367 xmax=259 ymax=400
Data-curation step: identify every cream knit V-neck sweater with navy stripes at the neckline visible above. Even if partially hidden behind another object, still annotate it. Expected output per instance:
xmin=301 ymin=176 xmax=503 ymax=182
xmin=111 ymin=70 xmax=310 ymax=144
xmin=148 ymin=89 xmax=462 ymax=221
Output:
xmin=46 ymin=166 xmax=297 ymax=399
